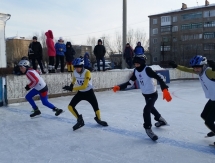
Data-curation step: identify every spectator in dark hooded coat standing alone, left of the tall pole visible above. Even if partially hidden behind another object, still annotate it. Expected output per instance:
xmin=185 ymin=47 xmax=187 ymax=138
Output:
xmin=93 ymin=39 xmax=106 ymax=71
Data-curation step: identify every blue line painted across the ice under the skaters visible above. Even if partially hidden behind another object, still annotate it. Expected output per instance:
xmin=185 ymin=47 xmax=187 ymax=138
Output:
xmin=5 ymin=108 xmax=215 ymax=155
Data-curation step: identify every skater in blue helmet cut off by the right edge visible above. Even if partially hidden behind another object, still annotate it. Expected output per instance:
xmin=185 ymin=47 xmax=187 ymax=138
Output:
xmin=169 ymin=55 xmax=215 ymax=137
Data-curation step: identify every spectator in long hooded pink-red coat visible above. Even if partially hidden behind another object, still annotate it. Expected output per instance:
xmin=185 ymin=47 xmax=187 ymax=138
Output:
xmin=45 ymin=30 xmax=56 ymax=73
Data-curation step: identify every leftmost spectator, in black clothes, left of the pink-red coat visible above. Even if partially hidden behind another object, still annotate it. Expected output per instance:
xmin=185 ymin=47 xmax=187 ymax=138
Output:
xmin=28 ymin=36 xmax=46 ymax=74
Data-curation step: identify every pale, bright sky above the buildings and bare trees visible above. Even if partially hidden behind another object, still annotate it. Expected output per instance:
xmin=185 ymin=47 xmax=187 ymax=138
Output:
xmin=0 ymin=0 xmax=215 ymax=44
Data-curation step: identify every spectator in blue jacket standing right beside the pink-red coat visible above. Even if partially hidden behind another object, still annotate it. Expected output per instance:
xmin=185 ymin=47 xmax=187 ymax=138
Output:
xmin=55 ymin=37 xmax=66 ymax=72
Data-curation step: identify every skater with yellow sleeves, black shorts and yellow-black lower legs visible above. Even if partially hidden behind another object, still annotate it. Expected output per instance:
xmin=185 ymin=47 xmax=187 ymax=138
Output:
xmin=63 ymin=58 xmax=108 ymax=130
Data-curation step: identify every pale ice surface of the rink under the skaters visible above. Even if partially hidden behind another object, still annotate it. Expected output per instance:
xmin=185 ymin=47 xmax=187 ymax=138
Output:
xmin=0 ymin=80 xmax=215 ymax=163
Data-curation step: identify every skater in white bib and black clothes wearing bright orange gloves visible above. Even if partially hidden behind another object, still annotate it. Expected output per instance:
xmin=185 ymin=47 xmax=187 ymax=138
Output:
xmin=113 ymin=56 xmax=172 ymax=141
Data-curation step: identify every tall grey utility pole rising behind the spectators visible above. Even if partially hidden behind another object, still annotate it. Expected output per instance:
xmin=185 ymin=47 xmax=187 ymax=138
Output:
xmin=122 ymin=0 xmax=127 ymax=69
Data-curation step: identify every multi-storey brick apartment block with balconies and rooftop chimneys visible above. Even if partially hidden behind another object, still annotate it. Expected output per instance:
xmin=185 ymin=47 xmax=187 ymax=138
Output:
xmin=148 ymin=0 xmax=215 ymax=67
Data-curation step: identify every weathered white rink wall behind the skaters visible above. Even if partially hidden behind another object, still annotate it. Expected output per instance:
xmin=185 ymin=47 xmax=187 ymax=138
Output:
xmin=5 ymin=69 xmax=198 ymax=104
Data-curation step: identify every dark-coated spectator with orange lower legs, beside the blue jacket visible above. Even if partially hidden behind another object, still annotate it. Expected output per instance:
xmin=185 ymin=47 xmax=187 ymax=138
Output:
xmin=65 ymin=42 xmax=76 ymax=72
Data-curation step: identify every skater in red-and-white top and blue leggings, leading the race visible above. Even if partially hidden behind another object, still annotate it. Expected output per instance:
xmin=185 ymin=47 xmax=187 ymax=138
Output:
xmin=18 ymin=60 xmax=63 ymax=117
